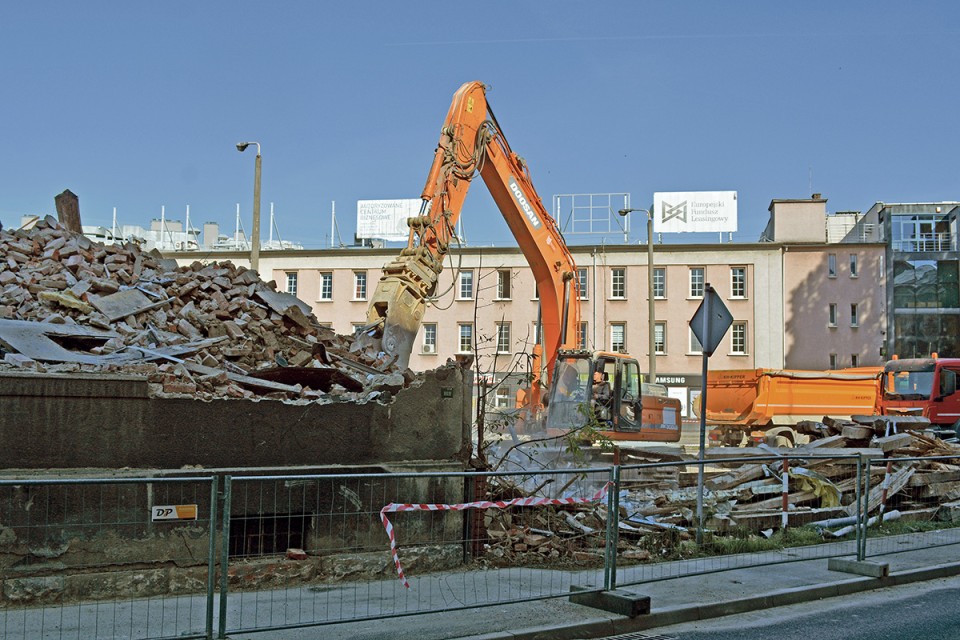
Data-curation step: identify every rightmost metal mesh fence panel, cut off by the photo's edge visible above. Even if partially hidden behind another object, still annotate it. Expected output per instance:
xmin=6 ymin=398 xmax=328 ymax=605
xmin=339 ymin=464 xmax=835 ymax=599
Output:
xmin=864 ymin=456 xmax=960 ymax=556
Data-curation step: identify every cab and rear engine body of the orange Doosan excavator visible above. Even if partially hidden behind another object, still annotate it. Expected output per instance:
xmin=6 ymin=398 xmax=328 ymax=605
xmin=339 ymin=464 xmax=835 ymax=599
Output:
xmin=546 ymin=350 xmax=680 ymax=442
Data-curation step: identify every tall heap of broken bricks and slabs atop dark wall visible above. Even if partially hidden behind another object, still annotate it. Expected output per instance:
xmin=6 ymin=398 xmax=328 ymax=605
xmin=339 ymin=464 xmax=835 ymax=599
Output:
xmin=0 ymin=217 xmax=404 ymax=401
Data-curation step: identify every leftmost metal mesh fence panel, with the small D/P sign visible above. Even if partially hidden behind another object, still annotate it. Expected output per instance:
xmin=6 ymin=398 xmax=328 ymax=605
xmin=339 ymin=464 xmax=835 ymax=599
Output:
xmin=0 ymin=477 xmax=217 ymax=640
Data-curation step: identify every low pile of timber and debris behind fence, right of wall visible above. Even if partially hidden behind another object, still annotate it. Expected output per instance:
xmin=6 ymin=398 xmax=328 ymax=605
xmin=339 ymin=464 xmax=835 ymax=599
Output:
xmin=486 ymin=416 xmax=960 ymax=562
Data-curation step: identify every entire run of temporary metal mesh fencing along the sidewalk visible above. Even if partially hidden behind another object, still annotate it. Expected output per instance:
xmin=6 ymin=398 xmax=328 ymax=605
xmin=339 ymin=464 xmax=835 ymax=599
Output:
xmin=0 ymin=450 xmax=960 ymax=639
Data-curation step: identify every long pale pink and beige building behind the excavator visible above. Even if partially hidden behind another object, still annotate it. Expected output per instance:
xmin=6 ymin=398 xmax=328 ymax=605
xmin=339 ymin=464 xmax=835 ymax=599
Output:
xmin=176 ymin=196 xmax=885 ymax=417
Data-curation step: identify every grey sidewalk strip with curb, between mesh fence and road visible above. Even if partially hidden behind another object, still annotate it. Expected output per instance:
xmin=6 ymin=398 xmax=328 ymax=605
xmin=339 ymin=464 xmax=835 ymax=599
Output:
xmin=230 ymin=534 xmax=960 ymax=640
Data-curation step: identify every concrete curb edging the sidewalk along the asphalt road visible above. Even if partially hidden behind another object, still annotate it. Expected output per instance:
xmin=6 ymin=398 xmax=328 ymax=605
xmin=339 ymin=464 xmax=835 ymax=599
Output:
xmin=460 ymin=562 xmax=960 ymax=640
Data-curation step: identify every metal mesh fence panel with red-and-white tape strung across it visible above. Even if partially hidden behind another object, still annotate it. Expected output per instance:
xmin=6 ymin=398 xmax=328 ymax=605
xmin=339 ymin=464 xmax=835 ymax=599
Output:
xmin=219 ymin=469 xmax=614 ymax=636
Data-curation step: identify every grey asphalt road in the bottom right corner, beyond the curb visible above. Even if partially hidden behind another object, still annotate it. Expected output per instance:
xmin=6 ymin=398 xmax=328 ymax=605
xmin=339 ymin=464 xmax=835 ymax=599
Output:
xmin=632 ymin=577 xmax=960 ymax=640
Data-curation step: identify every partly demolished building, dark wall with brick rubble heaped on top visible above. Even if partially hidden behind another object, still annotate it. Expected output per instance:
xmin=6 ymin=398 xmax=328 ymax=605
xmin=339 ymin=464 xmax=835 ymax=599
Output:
xmin=0 ymin=217 xmax=471 ymax=469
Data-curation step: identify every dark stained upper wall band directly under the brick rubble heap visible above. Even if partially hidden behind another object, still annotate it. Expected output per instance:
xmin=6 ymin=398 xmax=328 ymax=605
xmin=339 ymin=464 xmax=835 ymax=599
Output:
xmin=0 ymin=364 xmax=471 ymax=469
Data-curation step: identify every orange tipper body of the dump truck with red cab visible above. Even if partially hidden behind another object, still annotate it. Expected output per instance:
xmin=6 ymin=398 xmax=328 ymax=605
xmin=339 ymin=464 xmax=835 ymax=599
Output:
xmin=706 ymin=367 xmax=883 ymax=446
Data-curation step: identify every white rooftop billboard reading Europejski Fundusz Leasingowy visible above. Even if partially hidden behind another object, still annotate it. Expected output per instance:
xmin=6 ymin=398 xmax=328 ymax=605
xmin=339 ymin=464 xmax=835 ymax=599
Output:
xmin=653 ymin=191 xmax=737 ymax=233
